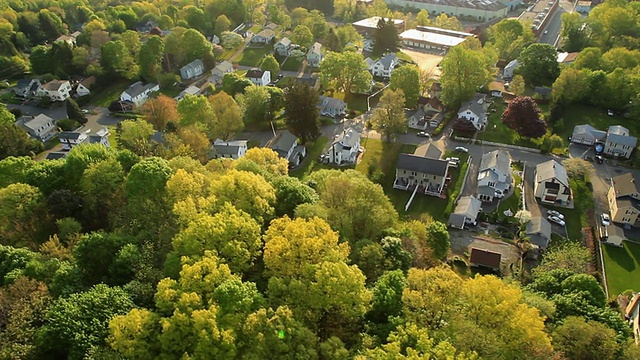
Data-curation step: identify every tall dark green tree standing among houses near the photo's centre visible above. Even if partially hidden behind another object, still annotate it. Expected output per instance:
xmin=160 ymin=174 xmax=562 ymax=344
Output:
xmin=284 ymin=82 xmax=320 ymax=144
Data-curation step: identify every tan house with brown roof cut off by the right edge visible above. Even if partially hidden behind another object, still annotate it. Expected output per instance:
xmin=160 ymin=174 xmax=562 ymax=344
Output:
xmin=607 ymin=172 xmax=640 ymax=226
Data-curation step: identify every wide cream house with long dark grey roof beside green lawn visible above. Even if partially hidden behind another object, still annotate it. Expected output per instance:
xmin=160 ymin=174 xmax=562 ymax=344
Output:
xmin=393 ymin=150 xmax=449 ymax=197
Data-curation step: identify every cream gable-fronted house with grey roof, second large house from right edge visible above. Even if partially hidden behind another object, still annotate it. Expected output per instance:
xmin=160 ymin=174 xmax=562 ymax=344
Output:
xmin=533 ymin=160 xmax=571 ymax=205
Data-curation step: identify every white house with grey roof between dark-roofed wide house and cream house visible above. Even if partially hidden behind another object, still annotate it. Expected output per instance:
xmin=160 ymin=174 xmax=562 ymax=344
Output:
xmin=478 ymin=149 xmax=513 ymax=202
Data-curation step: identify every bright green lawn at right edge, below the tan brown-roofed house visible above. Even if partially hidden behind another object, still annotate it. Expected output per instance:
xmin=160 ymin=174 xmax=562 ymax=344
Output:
xmin=602 ymin=241 xmax=640 ymax=296
